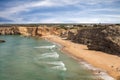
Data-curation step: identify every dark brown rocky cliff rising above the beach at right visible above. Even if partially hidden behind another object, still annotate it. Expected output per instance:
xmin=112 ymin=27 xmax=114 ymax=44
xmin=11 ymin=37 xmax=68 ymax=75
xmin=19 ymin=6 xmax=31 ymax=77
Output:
xmin=69 ymin=26 xmax=120 ymax=54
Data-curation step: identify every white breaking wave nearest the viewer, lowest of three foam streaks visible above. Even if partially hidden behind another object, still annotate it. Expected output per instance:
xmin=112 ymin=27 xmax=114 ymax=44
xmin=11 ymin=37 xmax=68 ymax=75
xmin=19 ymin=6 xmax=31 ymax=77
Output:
xmin=47 ymin=61 xmax=67 ymax=71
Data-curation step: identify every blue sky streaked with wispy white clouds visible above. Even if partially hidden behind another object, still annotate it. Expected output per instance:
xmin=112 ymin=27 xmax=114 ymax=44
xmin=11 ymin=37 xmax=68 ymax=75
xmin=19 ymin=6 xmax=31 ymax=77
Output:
xmin=0 ymin=0 xmax=120 ymax=23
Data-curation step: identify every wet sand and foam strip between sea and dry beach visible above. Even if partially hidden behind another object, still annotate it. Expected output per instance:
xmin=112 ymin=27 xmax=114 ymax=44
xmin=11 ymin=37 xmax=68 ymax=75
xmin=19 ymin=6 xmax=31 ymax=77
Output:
xmin=61 ymin=50 xmax=115 ymax=80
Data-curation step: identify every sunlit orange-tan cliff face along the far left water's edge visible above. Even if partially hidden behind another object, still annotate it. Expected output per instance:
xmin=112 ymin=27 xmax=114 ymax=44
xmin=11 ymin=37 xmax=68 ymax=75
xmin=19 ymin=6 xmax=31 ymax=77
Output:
xmin=0 ymin=26 xmax=60 ymax=36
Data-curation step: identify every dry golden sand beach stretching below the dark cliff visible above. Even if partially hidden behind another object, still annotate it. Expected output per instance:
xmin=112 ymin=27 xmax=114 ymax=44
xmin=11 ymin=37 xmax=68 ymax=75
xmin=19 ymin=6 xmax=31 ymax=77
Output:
xmin=43 ymin=35 xmax=120 ymax=80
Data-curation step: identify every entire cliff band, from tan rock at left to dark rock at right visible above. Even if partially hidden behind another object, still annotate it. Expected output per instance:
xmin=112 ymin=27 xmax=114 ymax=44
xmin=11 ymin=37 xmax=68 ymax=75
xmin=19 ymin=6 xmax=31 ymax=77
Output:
xmin=0 ymin=26 xmax=120 ymax=54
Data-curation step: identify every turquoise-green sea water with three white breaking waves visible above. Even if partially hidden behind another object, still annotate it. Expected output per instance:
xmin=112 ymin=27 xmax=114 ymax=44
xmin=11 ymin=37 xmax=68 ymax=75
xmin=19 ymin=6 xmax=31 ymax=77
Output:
xmin=0 ymin=36 xmax=93 ymax=80
